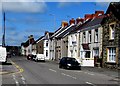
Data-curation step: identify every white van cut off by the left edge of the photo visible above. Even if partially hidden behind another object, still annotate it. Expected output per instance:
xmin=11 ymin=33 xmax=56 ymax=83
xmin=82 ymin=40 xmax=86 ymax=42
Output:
xmin=0 ymin=46 xmax=7 ymax=62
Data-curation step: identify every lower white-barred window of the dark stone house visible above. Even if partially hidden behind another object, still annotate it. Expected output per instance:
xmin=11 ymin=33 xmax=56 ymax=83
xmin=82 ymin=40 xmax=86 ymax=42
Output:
xmin=108 ymin=47 xmax=116 ymax=62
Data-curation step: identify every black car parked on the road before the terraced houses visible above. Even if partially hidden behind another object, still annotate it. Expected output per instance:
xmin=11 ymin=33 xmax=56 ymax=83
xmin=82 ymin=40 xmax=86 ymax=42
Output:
xmin=59 ymin=57 xmax=81 ymax=70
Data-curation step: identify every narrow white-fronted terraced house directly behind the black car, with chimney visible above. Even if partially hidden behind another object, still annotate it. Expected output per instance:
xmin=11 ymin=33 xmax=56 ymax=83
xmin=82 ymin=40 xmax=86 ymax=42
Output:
xmin=68 ymin=17 xmax=84 ymax=63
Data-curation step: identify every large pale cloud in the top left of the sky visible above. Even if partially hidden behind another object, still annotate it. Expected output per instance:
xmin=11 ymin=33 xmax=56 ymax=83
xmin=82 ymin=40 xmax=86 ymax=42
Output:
xmin=2 ymin=0 xmax=47 ymax=13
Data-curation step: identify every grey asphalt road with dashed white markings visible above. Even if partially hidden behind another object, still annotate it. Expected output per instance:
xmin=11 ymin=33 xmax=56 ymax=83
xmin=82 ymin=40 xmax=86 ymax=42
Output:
xmin=2 ymin=57 xmax=118 ymax=86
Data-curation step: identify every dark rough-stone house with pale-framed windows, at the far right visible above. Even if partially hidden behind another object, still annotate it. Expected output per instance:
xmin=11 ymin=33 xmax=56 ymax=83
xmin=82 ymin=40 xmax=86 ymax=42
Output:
xmin=102 ymin=2 xmax=120 ymax=68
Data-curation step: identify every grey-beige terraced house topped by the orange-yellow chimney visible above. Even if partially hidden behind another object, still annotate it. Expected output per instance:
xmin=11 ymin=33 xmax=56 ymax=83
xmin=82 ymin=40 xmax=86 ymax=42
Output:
xmin=50 ymin=21 xmax=68 ymax=61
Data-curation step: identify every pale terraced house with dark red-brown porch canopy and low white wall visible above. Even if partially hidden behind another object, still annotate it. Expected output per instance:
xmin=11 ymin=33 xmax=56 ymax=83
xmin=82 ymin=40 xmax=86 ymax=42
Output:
xmin=79 ymin=11 xmax=104 ymax=67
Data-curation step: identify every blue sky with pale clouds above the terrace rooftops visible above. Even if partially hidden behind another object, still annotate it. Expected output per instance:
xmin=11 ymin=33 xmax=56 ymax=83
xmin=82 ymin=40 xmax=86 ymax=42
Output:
xmin=0 ymin=0 xmax=118 ymax=46
